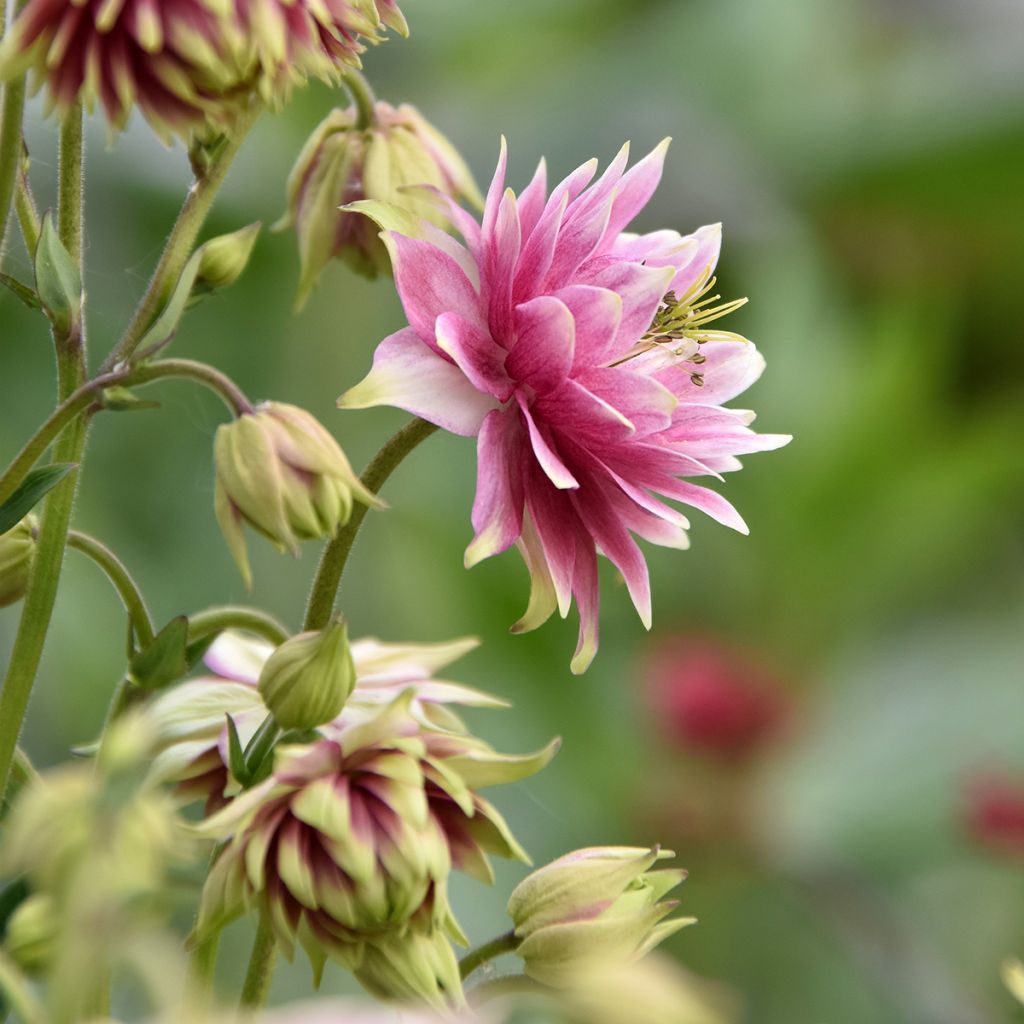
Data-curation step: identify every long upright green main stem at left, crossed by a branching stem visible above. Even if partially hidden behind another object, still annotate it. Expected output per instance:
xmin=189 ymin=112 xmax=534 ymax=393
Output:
xmin=0 ymin=108 xmax=88 ymax=793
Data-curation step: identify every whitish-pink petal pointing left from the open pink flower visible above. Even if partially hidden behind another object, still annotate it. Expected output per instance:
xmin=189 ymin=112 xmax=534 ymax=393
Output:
xmin=338 ymin=328 xmax=498 ymax=437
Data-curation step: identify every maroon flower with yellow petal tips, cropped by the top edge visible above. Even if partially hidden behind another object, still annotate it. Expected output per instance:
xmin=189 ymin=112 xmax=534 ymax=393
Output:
xmin=0 ymin=0 xmax=408 ymax=138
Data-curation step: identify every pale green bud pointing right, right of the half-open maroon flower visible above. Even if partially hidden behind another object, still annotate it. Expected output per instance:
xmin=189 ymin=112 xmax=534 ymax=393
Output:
xmin=508 ymin=847 xmax=695 ymax=988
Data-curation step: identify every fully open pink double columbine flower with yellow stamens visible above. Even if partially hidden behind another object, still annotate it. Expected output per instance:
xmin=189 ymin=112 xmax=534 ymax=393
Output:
xmin=339 ymin=140 xmax=790 ymax=673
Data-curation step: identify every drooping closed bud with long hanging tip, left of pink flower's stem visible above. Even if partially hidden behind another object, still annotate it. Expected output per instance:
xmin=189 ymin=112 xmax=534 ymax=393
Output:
xmin=213 ymin=401 xmax=383 ymax=586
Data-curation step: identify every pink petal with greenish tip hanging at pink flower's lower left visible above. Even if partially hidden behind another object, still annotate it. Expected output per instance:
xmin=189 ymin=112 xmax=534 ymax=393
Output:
xmin=466 ymin=408 xmax=526 ymax=568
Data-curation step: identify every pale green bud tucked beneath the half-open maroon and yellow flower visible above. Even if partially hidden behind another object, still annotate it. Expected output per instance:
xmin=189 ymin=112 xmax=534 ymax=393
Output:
xmin=352 ymin=931 xmax=465 ymax=1009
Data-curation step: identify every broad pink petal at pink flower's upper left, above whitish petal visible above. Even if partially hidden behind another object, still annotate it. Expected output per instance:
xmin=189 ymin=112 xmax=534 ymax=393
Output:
xmin=384 ymin=231 xmax=482 ymax=345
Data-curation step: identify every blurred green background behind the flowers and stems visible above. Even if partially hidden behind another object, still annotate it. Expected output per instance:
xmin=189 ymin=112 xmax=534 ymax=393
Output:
xmin=0 ymin=0 xmax=1024 ymax=1024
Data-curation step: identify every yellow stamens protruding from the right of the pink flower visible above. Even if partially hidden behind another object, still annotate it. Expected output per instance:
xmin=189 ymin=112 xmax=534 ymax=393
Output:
xmin=612 ymin=268 xmax=746 ymax=387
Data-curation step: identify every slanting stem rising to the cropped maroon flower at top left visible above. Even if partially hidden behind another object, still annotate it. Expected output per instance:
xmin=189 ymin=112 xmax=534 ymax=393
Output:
xmin=102 ymin=101 xmax=262 ymax=371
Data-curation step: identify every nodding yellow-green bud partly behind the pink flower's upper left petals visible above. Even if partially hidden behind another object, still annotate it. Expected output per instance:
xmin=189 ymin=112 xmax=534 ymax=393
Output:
xmin=278 ymin=101 xmax=482 ymax=306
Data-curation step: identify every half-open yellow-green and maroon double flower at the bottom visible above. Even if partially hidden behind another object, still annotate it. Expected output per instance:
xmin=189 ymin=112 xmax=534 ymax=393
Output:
xmin=197 ymin=690 xmax=553 ymax=1005
